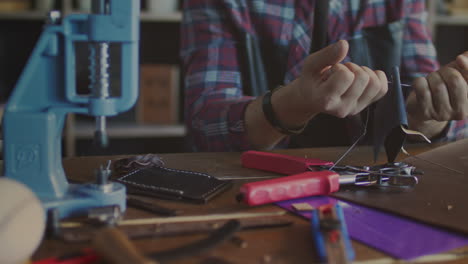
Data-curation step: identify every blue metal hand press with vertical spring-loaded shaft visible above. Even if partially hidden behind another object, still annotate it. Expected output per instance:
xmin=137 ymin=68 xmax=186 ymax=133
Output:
xmin=3 ymin=0 xmax=140 ymax=218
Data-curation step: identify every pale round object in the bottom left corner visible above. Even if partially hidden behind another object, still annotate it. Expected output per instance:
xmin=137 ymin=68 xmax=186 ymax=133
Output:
xmin=0 ymin=177 xmax=46 ymax=264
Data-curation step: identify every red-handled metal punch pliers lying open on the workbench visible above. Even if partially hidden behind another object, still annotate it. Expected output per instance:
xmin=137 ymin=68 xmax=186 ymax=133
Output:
xmin=239 ymin=151 xmax=417 ymax=205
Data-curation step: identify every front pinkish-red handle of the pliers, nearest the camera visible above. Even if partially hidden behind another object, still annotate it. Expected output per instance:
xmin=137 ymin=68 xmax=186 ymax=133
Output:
xmin=240 ymin=171 xmax=340 ymax=205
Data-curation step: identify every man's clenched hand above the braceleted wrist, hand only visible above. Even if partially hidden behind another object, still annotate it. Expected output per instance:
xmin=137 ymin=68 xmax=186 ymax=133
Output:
xmin=297 ymin=40 xmax=388 ymax=118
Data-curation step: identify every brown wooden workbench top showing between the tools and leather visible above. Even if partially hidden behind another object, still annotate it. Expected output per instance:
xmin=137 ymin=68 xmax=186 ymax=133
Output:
xmin=33 ymin=145 xmax=468 ymax=264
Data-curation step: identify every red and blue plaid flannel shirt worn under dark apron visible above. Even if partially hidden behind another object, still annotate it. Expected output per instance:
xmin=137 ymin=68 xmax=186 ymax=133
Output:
xmin=181 ymin=0 xmax=468 ymax=151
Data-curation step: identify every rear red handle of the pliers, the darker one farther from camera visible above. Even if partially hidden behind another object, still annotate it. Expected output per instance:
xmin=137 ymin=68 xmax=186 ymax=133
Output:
xmin=241 ymin=150 xmax=333 ymax=175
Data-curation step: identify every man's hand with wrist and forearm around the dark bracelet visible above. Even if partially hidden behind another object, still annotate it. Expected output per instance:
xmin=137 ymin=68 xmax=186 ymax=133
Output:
xmin=245 ymin=41 xmax=388 ymax=149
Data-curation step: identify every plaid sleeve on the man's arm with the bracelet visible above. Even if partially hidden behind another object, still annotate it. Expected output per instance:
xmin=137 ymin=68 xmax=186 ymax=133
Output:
xmin=181 ymin=0 xmax=253 ymax=151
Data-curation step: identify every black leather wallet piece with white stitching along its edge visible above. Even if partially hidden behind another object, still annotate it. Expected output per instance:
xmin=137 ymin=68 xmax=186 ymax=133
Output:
xmin=116 ymin=166 xmax=232 ymax=203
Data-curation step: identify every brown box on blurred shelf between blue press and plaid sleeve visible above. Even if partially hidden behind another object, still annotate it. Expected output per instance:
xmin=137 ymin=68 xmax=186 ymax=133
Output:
xmin=137 ymin=64 xmax=179 ymax=125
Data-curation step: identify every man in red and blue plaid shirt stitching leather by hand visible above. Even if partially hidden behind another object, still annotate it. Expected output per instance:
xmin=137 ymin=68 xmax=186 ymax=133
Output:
xmin=181 ymin=0 xmax=468 ymax=151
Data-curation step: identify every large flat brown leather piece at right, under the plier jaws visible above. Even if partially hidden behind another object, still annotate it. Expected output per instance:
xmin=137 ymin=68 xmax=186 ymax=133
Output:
xmin=333 ymin=139 xmax=468 ymax=235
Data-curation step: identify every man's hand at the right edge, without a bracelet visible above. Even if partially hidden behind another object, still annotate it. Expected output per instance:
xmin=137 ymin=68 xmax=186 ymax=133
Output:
xmin=407 ymin=52 xmax=468 ymax=137
